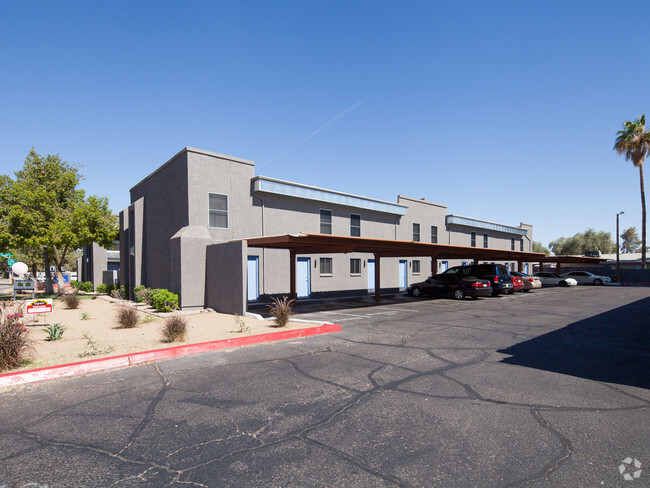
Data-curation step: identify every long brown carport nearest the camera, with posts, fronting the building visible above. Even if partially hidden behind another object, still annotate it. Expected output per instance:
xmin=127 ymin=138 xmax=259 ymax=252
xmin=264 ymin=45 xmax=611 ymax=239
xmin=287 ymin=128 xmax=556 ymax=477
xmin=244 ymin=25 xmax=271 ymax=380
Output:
xmin=245 ymin=234 xmax=544 ymax=300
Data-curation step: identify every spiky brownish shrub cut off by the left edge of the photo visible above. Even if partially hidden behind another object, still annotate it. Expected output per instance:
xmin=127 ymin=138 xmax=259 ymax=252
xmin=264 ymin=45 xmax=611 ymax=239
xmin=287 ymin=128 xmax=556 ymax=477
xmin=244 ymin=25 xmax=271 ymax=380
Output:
xmin=0 ymin=300 xmax=32 ymax=371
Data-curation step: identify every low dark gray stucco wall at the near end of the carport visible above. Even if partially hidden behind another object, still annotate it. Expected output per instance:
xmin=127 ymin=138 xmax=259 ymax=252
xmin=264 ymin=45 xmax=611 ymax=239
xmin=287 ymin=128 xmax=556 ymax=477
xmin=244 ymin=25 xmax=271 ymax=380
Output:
xmin=205 ymin=241 xmax=248 ymax=314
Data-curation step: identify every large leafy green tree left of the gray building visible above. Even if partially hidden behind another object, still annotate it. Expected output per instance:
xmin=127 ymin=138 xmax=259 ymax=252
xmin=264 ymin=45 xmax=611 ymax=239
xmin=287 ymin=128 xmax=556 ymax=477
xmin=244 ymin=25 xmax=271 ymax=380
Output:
xmin=0 ymin=149 xmax=117 ymax=294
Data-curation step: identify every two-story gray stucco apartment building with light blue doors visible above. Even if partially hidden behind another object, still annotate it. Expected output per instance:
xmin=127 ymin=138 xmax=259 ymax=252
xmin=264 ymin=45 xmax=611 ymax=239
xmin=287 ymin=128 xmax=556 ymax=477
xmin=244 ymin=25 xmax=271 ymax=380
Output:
xmin=120 ymin=148 xmax=533 ymax=308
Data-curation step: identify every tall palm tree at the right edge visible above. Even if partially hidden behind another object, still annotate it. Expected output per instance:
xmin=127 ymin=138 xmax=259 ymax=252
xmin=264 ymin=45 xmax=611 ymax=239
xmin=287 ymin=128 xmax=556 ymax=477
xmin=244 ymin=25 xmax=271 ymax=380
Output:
xmin=614 ymin=114 xmax=650 ymax=269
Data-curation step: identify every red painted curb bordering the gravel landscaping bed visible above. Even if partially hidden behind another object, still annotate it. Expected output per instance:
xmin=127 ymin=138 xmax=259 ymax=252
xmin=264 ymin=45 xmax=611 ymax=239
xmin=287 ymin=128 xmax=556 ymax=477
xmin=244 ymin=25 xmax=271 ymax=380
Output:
xmin=0 ymin=324 xmax=343 ymax=388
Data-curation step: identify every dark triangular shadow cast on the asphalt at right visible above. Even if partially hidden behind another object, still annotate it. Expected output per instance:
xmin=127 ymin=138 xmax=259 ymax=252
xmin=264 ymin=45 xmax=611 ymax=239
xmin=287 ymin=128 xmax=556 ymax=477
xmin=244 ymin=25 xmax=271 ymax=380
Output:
xmin=499 ymin=298 xmax=650 ymax=389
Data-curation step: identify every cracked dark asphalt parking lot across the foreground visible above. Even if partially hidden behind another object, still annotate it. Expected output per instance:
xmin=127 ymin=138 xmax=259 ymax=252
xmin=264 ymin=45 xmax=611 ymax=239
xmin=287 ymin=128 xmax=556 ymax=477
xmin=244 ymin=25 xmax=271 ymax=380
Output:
xmin=0 ymin=287 xmax=650 ymax=488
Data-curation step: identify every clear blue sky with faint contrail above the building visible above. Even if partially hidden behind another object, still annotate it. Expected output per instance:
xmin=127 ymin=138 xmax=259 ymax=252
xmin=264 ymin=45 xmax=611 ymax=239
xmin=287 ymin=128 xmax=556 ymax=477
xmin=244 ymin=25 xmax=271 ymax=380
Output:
xmin=0 ymin=0 xmax=650 ymax=245
